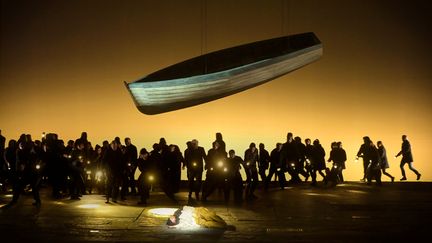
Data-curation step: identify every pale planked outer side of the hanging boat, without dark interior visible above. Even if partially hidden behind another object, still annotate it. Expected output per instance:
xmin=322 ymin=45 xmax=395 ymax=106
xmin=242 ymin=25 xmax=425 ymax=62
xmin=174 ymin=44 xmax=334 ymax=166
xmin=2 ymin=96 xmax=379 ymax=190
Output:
xmin=125 ymin=33 xmax=322 ymax=115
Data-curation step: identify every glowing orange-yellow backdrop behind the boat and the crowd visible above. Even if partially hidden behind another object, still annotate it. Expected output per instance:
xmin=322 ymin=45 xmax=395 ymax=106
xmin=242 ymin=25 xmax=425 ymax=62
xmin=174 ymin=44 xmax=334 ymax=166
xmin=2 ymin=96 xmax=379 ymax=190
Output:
xmin=0 ymin=0 xmax=432 ymax=181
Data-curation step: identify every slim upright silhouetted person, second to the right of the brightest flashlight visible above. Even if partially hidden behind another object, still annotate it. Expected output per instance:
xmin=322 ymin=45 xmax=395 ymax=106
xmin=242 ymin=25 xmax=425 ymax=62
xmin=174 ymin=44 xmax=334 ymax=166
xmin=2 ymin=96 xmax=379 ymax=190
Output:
xmin=243 ymin=143 xmax=258 ymax=200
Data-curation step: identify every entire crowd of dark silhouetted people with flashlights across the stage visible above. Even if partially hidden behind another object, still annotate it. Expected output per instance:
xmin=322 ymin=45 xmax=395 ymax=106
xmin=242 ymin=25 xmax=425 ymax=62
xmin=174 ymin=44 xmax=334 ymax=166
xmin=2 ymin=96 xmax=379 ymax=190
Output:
xmin=0 ymin=130 xmax=421 ymax=206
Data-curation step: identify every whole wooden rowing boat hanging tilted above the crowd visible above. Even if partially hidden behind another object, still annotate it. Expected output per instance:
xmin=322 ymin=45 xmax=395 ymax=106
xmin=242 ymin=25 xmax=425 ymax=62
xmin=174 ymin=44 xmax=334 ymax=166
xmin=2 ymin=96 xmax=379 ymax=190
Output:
xmin=125 ymin=33 xmax=322 ymax=115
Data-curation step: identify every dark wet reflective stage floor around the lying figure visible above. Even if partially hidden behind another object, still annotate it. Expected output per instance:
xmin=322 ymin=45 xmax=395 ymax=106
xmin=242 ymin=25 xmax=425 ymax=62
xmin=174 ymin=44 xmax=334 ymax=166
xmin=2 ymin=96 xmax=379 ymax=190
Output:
xmin=0 ymin=182 xmax=432 ymax=242
